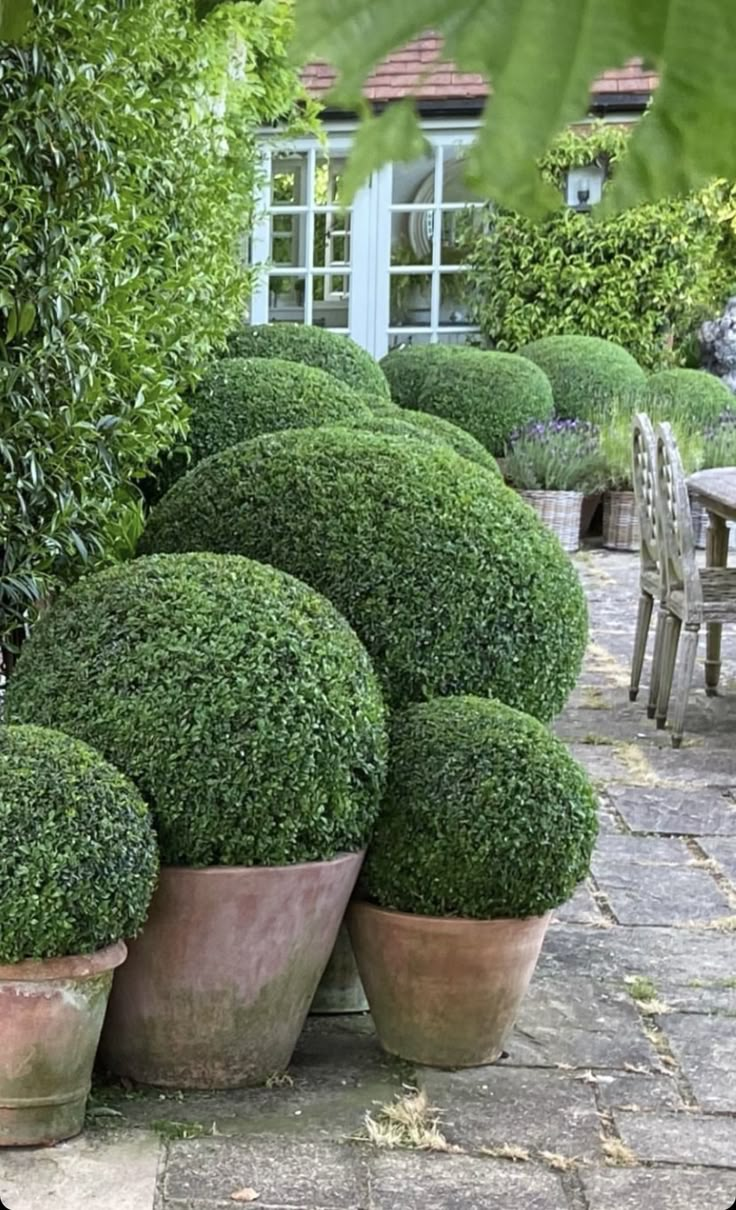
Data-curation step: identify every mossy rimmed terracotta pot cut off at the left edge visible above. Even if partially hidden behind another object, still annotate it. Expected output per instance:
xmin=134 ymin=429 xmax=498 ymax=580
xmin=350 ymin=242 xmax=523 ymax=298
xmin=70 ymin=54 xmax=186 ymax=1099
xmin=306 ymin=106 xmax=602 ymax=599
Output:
xmin=0 ymin=941 xmax=126 ymax=1147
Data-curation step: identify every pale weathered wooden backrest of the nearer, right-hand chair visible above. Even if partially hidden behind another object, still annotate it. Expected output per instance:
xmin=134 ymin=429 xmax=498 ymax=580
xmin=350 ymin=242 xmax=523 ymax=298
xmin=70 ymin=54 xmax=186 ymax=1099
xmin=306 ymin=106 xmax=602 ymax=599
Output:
xmin=656 ymin=424 xmax=702 ymax=613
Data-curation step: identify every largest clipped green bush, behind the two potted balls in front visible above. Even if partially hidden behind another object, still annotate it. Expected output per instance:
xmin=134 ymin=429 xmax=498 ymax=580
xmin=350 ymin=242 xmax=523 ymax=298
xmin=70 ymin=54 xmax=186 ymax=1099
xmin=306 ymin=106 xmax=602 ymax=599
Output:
xmin=142 ymin=428 xmax=586 ymax=719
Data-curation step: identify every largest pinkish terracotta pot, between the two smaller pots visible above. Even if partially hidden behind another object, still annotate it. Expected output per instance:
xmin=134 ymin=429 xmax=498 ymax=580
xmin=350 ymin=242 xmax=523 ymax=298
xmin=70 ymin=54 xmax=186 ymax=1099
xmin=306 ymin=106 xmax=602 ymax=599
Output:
xmin=100 ymin=853 xmax=363 ymax=1088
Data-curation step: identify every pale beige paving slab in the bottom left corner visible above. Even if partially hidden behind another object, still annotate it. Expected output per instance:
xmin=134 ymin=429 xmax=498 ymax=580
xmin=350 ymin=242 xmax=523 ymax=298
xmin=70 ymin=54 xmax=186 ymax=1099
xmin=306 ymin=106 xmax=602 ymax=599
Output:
xmin=0 ymin=1133 xmax=161 ymax=1210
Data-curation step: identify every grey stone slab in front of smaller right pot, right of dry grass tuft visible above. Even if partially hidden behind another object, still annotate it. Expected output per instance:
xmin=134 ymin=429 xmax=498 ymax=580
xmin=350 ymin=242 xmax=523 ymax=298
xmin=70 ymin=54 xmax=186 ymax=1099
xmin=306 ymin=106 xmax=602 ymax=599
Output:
xmin=418 ymin=1066 xmax=600 ymax=1158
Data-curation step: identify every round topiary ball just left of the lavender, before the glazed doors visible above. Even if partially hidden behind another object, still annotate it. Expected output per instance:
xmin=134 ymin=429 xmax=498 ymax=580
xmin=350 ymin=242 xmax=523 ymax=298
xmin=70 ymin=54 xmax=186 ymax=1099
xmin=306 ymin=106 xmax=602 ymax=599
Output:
xmin=414 ymin=348 xmax=552 ymax=456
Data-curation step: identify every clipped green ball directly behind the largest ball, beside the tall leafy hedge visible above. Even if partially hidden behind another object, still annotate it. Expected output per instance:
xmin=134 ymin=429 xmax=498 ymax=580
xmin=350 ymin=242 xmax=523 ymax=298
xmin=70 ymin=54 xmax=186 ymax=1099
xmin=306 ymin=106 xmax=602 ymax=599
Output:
xmin=156 ymin=357 xmax=370 ymax=486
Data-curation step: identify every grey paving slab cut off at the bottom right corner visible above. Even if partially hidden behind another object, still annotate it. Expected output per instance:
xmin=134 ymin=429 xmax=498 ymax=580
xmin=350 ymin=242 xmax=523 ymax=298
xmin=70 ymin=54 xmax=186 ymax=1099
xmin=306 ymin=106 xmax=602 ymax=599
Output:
xmin=581 ymin=1168 xmax=736 ymax=1210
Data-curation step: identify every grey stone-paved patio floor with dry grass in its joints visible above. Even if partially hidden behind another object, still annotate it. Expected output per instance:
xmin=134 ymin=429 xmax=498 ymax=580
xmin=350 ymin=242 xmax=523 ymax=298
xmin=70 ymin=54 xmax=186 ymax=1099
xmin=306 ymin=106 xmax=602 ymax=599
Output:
xmin=0 ymin=551 xmax=736 ymax=1210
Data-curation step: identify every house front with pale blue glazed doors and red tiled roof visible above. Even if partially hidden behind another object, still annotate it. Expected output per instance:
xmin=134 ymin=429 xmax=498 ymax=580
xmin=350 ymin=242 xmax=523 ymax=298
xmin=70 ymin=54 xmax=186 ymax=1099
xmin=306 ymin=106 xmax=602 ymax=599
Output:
xmin=251 ymin=35 xmax=656 ymax=358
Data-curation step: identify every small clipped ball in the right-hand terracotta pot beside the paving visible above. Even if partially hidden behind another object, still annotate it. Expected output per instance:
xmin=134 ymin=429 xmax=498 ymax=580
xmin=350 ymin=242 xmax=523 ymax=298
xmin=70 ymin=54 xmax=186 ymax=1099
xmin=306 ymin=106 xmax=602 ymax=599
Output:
xmin=362 ymin=697 xmax=597 ymax=920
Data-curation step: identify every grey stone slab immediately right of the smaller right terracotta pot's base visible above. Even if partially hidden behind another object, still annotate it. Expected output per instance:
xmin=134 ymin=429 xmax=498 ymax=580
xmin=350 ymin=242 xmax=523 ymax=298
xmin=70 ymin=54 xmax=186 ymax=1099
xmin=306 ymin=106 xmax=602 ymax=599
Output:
xmin=506 ymin=979 xmax=656 ymax=1068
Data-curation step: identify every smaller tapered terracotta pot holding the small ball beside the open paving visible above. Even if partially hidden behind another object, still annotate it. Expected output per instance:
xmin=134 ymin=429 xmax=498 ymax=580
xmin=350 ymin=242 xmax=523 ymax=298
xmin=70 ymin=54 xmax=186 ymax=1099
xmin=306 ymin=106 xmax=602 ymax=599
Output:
xmin=347 ymin=903 xmax=550 ymax=1067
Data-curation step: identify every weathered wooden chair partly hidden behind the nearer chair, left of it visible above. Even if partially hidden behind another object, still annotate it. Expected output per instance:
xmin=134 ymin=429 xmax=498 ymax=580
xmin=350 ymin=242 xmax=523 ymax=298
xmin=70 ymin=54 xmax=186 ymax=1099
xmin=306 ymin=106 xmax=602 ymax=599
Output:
xmin=628 ymin=413 xmax=667 ymax=719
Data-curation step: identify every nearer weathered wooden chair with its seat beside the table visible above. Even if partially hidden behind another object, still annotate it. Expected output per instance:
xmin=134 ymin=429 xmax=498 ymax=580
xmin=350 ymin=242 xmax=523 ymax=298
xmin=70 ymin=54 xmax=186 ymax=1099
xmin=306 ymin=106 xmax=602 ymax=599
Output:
xmin=656 ymin=425 xmax=736 ymax=748
